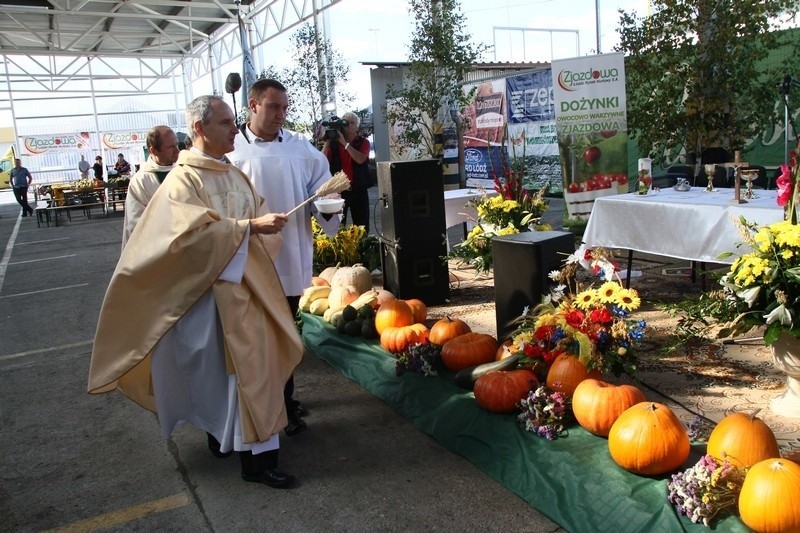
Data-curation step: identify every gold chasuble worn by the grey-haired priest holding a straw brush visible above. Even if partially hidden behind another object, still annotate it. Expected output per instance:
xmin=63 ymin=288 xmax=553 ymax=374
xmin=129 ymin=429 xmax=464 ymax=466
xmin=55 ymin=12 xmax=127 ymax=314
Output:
xmin=89 ymin=151 xmax=303 ymax=443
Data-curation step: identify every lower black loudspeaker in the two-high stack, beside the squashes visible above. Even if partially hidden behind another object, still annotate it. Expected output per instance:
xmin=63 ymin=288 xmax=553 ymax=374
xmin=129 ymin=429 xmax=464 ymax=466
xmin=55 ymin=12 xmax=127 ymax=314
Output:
xmin=381 ymin=237 xmax=450 ymax=305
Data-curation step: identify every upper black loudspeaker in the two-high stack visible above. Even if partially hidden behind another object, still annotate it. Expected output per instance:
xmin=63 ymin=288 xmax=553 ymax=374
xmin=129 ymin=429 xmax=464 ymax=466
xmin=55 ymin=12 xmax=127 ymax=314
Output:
xmin=378 ymin=159 xmax=445 ymax=244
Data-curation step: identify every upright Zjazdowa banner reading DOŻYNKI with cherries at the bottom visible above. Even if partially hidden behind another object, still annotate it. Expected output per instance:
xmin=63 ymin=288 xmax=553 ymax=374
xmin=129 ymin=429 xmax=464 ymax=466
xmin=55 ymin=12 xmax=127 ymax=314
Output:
xmin=552 ymin=53 xmax=628 ymax=219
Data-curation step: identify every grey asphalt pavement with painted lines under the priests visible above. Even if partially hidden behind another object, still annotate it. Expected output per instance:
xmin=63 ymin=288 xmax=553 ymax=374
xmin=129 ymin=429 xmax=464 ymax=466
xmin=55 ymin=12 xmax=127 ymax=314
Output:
xmin=0 ymin=191 xmax=560 ymax=532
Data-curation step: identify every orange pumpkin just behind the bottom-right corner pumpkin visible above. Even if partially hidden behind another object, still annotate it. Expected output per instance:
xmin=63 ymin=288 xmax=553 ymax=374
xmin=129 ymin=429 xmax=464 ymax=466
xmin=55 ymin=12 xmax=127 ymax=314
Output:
xmin=708 ymin=413 xmax=781 ymax=467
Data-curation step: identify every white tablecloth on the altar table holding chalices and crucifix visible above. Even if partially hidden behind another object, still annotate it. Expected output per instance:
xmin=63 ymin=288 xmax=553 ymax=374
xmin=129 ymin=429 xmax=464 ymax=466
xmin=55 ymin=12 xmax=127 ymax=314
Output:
xmin=583 ymin=187 xmax=783 ymax=263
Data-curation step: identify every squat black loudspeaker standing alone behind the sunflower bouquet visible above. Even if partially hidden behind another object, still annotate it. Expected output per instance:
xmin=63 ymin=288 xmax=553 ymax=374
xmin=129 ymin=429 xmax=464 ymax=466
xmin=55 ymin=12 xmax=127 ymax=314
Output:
xmin=492 ymin=231 xmax=575 ymax=341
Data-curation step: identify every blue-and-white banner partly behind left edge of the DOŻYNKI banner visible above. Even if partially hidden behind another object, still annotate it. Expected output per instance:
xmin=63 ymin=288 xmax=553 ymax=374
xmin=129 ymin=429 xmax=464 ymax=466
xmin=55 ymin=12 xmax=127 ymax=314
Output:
xmin=506 ymin=68 xmax=562 ymax=192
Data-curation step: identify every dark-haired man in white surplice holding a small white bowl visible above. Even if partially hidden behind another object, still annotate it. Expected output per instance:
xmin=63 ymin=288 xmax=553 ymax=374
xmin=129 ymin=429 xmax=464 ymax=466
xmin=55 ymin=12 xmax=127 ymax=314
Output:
xmin=228 ymin=79 xmax=340 ymax=436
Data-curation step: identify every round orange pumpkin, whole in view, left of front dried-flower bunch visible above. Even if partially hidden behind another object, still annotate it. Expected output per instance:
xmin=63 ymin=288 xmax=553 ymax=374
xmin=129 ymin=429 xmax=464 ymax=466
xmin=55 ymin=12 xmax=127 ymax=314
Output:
xmin=608 ymin=402 xmax=690 ymax=476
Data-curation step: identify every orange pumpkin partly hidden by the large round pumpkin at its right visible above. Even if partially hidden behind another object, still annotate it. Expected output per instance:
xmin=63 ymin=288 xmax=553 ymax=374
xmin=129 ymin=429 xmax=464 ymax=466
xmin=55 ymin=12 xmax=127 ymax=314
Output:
xmin=572 ymin=378 xmax=646 ymax=437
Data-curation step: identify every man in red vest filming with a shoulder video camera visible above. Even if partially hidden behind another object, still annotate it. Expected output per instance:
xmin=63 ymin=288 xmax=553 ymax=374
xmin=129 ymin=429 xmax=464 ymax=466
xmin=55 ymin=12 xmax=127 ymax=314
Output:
xmin=322 ymin=113 xmax=370 ymax=231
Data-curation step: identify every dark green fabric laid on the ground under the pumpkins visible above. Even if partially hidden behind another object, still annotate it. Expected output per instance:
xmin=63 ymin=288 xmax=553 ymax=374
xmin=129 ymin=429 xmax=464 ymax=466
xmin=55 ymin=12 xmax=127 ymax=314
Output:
xmin=303 ymin=314 xmax=748 ymax=532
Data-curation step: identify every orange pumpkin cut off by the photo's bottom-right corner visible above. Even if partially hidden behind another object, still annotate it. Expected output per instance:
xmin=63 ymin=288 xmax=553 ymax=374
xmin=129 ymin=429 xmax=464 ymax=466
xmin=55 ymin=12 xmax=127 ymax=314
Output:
xmin=739 ymin=459 xmax=800 ymax=533
